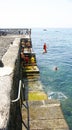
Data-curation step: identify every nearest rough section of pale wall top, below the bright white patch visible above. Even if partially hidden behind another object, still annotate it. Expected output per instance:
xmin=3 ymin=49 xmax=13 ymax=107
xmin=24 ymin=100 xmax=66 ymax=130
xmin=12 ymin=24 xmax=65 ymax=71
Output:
xmin=0 ymin=75 xmax=12 ymax=129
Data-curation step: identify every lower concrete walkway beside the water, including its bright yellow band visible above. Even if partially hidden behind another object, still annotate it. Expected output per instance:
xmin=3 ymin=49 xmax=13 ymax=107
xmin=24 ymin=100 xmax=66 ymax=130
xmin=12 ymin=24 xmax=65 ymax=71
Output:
xmin=22 ymin=77 xmax=69 ymax=130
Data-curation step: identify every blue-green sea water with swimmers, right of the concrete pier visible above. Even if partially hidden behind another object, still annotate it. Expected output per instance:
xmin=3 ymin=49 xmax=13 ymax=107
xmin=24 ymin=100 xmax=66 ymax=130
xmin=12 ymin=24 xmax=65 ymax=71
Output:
xmin=31 ymin=28 xmax=72 ymax=130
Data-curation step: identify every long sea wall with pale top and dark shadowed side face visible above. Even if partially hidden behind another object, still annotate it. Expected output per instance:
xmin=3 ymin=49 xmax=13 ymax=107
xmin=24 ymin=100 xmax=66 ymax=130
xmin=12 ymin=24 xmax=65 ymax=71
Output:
xmin=0 ymin=36 xmax=21 ymax=130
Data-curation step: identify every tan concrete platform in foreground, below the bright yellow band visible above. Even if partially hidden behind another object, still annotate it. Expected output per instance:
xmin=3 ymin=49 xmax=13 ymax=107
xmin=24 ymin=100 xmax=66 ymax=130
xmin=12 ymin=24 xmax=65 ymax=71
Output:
xmin=22 ymin=100 xmax=69 ymax=130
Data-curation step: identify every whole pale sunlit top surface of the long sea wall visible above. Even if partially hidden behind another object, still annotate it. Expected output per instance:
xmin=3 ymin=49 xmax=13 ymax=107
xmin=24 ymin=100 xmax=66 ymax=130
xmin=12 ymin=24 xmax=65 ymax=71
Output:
xmin=0 ymin=38 xmax=20 ymax=130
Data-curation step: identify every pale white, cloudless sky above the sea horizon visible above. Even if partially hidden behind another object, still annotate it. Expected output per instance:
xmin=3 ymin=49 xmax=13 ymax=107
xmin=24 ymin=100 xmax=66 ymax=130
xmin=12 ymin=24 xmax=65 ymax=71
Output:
xmin=0 ymin=0 xmax=72 ymax=28
